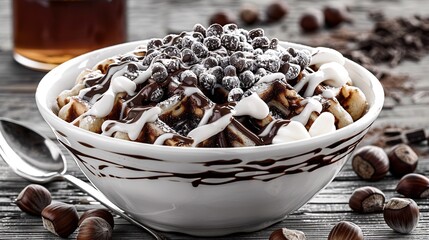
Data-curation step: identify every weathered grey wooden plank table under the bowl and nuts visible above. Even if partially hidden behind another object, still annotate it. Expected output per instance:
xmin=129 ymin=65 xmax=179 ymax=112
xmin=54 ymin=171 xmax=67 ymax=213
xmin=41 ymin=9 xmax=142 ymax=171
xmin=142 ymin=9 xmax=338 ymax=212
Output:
xmin=0 ymin=0 xmax=429 ymax=239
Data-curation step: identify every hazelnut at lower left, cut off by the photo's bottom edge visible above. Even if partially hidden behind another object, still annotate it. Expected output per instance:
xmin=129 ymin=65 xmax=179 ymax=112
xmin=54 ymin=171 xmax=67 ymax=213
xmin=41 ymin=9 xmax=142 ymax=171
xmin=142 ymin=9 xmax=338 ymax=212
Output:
xmin=76 ymin=217 xmax=112 ymax=240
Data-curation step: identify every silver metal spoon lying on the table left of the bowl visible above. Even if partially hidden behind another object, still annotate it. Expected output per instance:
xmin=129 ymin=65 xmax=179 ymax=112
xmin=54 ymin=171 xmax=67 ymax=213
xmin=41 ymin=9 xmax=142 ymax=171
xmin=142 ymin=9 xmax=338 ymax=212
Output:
xmin=0 ymin=118 xmax=167 ymax=240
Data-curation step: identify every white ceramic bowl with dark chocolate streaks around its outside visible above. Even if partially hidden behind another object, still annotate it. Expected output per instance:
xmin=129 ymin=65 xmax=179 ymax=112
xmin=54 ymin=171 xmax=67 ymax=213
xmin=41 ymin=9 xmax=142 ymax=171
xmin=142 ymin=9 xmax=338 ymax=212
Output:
xmin=36 ymin=41 xmax=384 ymax=236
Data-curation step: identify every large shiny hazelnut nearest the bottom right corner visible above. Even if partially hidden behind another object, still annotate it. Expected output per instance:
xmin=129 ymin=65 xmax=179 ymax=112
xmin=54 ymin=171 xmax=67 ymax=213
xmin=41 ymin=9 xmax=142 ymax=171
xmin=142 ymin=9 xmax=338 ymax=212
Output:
xmin=383 ymin=198 xmax=420 ymax=233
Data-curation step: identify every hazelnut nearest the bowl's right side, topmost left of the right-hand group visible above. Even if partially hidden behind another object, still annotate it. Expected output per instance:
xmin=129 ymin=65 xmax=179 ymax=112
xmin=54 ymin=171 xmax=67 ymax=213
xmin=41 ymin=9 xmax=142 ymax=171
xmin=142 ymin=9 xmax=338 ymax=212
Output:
xmin=352 ymin=145 xmax=389 ymax=181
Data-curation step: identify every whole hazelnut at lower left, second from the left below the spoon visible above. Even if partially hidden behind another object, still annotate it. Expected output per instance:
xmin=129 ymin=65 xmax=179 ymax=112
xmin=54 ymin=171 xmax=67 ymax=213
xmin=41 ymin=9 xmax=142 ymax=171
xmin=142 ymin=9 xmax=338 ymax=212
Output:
xmin=42 ymin=202 xmax=79 ymax=238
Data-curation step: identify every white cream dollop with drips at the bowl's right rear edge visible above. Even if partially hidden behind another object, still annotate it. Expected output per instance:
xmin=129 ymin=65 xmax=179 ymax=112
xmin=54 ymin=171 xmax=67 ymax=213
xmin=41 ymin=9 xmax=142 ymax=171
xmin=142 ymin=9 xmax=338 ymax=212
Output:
xmin=294 ymin=62 xmax=351 ymax=97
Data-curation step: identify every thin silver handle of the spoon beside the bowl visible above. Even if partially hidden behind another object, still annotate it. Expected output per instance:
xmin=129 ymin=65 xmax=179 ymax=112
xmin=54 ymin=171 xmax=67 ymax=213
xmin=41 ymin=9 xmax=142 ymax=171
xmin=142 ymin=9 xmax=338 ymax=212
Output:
xmin=63 ymin=174 xmax=167 ymax=240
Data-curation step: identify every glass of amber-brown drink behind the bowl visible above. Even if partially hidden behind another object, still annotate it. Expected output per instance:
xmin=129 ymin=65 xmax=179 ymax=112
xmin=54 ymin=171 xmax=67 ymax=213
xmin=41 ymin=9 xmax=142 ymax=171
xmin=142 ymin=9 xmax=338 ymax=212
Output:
xmin=12 ymin=0 xmax=127 ymax=71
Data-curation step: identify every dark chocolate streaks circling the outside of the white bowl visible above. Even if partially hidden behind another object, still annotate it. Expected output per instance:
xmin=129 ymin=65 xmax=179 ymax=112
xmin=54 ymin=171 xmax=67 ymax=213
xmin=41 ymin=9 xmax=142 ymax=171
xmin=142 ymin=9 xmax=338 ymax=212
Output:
xmin=60 ymin=125 xmax=368 ymax=187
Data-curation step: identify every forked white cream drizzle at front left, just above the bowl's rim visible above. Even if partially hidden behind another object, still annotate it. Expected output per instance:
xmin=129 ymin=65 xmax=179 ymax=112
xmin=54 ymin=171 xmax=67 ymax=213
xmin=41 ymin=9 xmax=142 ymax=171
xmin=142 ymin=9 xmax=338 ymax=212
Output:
xmin=101 ymin=107 xmax=161 ymax=141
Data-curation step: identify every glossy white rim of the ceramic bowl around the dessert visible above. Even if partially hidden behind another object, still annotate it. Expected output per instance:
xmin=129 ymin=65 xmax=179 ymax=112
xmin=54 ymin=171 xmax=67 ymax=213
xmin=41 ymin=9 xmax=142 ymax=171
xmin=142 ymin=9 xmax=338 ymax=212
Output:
xmin=35 ymin=40 xmax=384 ymax=154
